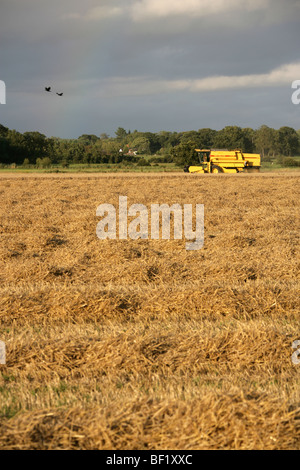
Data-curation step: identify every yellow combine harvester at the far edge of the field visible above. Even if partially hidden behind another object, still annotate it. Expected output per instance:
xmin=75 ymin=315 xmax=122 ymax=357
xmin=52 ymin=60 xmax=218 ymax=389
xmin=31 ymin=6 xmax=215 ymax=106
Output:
xmin=184 ymin=149 xmax=260 ymax=173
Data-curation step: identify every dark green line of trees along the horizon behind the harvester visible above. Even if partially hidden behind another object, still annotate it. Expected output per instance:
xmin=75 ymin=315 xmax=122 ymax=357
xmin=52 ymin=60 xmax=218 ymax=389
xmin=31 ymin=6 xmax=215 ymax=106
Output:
xmin=0 ymin=124 xmax=300 ymax=166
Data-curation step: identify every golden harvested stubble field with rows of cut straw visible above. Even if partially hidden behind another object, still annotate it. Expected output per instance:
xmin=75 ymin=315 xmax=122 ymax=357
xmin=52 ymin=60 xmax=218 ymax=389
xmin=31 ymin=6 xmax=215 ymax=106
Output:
xmin=0 ymin=173 xmax=300 ymax=450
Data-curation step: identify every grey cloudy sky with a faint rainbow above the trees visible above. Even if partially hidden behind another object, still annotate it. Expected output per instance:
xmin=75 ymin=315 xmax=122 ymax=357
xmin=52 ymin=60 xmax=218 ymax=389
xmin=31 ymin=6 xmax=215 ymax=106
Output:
xmin=0 ymin=0 xmax=300 ymax=138
